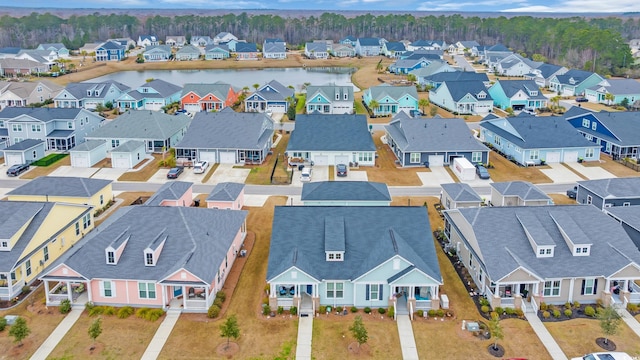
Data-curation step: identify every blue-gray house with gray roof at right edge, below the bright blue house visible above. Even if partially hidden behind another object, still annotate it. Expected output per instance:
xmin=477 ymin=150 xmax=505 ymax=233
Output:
xmin=576 ymin=177 xmax=640 ymax=210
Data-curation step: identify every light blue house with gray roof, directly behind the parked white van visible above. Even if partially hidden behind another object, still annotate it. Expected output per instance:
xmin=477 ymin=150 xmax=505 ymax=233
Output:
xmin=385 ymin=114 xmax=489 ymax=167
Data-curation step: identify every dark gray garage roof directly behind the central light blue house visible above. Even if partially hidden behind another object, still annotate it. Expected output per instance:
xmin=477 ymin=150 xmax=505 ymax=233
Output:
xmin=302 ymin=181 xmax=391 ymax=201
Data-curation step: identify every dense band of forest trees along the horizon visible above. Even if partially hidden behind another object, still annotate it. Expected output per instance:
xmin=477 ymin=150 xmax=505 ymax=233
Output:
xmin=0 ymin=13 xmax=640 ymax=74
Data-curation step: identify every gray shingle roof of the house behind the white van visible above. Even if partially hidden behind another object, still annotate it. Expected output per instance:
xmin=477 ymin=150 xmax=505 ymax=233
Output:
xmin=385 ymin=116 xmax=489 ymax=152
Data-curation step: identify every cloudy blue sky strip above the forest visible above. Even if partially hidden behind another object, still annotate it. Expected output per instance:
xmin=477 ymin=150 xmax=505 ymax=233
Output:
xmin=7 ymin=0 xmax=640 ymax=13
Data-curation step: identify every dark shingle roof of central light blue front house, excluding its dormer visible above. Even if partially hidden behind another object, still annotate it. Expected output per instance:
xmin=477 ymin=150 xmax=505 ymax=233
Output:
xmin=267 ymin=206 xmax=442 ymax=282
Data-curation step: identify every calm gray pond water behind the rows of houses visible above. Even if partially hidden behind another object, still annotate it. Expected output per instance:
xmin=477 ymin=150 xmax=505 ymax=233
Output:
xmin=88 ymin=68 xmax=359 ymax=92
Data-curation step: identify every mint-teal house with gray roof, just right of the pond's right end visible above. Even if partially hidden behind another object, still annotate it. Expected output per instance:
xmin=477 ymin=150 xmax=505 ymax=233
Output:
xmin=362 ymin=84 xmax=418 ymax=116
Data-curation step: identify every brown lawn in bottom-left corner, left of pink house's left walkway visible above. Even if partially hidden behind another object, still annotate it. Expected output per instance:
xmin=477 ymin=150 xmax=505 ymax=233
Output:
xmin=0 ymin=286 xmax=64 ymax=359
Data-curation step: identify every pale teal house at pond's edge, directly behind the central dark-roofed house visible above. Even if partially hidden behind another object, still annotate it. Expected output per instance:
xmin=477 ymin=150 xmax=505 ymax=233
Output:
xmin=305 ymin=85 xmax=354 ymax=114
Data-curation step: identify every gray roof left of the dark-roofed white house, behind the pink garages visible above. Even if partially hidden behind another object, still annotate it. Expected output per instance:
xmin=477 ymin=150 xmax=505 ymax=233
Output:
xmin=176 ymin=108 xmax=274 ymax=150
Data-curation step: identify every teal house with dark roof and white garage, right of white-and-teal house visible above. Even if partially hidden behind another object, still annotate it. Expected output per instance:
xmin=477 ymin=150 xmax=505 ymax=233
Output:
xmin=489 ymin=80 xmax=548 ymax=111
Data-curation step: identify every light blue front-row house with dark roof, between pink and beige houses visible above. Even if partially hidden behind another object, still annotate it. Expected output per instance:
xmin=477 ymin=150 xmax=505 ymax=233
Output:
xmin=267 ymin=206 xmax=442 ymax=316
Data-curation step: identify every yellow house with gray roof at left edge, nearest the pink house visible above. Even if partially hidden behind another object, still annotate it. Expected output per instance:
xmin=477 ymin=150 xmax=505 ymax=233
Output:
xmin=0 ymin=201 xmax=93 ymax=300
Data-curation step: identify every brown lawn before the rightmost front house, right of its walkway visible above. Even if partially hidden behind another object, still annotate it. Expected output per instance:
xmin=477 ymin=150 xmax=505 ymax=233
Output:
xmin=544 ymin=319 xmax=640 ymax=358
